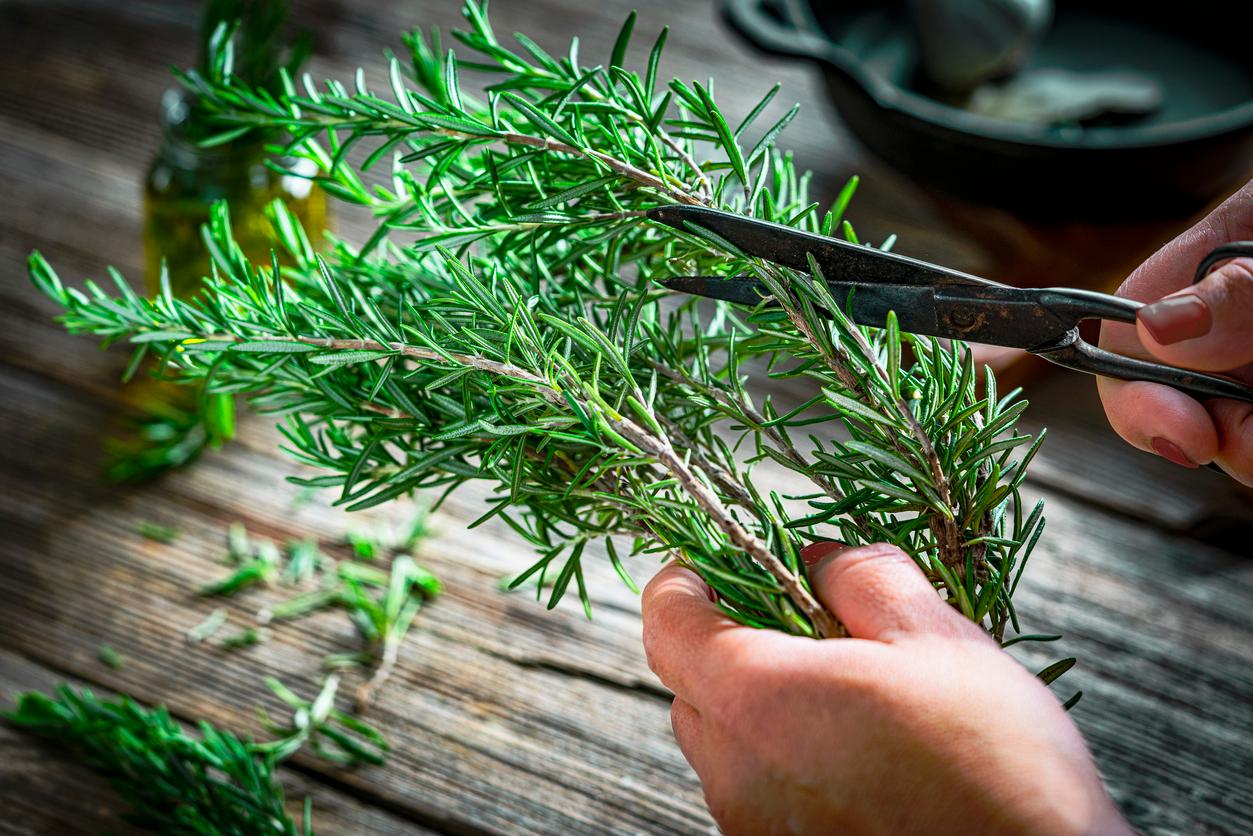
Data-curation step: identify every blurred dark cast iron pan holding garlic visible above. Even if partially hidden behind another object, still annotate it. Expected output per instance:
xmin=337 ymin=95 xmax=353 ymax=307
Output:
xmin=723 ymin=0 xmax=1253 ymax=222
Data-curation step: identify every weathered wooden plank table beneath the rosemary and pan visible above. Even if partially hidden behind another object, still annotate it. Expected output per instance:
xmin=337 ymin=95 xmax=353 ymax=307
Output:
xmin=0 ymin=0 xmax=1253 ymax=833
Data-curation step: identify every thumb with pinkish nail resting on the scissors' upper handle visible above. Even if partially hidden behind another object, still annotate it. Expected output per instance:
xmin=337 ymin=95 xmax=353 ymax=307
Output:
xmin=1136 ymin=258 xmax=1253 ymax=371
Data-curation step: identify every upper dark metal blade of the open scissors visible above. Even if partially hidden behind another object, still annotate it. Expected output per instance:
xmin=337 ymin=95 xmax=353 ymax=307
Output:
xmin=648 ymin=206 xmax=1001 ymax=287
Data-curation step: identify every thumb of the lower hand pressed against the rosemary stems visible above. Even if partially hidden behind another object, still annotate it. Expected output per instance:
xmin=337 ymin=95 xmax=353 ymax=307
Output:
xmin=809 ymin=543 xmax=986 ymax=642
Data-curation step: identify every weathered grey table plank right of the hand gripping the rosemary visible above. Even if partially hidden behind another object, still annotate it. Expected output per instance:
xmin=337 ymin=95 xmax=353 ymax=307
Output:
xmin=1016 ymin=495 xmax=1253 ymax=833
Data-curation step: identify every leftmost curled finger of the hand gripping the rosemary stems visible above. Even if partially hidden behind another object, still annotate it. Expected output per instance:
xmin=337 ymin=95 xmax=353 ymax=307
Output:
xmin=643 ymin=563 xmax=759 ymax=704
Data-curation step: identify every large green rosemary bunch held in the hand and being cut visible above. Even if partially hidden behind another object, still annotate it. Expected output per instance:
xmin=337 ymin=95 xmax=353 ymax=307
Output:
xmin=30 ymin=0 xmax=1044 ymax=651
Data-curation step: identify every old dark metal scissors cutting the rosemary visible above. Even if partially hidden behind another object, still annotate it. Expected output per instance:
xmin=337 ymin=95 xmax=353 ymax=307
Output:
xmin=648 ymin=206 xmax=1253 ymax=404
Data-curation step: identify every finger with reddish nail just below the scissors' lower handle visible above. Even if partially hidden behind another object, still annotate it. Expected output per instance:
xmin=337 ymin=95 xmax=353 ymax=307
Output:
xmin=1096 ymin=377 xmax=1219 ymax=468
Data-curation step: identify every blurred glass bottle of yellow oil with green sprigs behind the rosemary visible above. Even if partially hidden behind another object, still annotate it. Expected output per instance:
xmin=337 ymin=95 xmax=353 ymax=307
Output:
xmin=105 ymin=0 xmax=318 ymax=481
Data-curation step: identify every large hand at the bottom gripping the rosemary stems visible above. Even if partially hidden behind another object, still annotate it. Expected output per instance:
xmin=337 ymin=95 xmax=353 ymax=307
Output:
xmin=644 ymin=544 xmax=1130 ymax=835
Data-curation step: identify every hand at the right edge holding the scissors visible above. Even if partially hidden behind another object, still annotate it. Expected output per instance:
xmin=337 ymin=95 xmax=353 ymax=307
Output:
xmin=1096 ymin=180 xmax=1253 ymax=485
